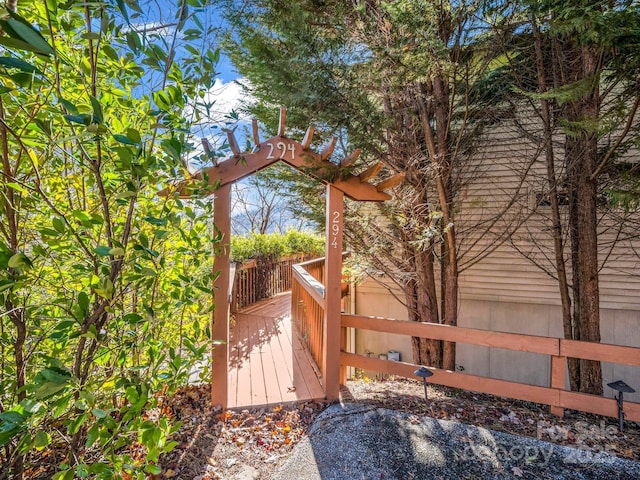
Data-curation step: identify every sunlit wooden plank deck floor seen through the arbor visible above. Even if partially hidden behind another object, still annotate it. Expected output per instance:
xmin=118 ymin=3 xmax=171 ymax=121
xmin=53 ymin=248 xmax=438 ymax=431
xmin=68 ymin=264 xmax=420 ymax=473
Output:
xmin=228 ymin=293 xmax=325 ymax=408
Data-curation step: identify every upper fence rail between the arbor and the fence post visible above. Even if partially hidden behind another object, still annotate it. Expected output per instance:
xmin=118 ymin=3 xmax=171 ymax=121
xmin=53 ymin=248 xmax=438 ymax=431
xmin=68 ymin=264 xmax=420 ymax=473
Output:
xmin=342 ymin=315 xmax=560 ymax=355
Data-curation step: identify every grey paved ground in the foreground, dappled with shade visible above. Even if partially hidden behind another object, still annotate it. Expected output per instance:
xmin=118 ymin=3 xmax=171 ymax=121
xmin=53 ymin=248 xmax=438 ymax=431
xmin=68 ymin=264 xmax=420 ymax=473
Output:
xmin=272 ymin=404 xmax=640 ymax=480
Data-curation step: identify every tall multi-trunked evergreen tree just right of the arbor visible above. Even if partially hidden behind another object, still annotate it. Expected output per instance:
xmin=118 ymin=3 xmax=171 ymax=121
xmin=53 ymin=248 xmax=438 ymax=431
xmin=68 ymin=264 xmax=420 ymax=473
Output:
xmin=220 ymin=0 xmax=520 ymax=369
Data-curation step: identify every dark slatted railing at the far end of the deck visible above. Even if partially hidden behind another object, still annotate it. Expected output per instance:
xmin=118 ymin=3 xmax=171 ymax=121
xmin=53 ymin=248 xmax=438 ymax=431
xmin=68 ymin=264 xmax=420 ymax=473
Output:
xmin=231 ymin=256 xmax=312 ymax=312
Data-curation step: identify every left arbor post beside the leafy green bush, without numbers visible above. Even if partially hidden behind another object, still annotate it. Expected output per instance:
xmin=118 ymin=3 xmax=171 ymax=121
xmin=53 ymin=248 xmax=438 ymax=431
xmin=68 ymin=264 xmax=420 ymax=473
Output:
xmin=211 ymin=184 xmax=231 ymax=408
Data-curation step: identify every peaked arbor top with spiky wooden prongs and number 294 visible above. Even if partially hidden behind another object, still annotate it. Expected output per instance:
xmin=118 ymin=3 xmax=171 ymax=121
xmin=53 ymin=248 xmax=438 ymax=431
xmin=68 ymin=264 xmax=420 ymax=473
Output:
xmin=159 ymin=107 xmax=405 ymax=202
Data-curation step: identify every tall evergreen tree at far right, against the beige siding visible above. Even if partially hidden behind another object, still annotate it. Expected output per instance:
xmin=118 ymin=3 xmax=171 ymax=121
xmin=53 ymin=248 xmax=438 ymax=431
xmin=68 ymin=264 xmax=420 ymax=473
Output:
xmin=491 ymin=0 xmax=640 ymax=394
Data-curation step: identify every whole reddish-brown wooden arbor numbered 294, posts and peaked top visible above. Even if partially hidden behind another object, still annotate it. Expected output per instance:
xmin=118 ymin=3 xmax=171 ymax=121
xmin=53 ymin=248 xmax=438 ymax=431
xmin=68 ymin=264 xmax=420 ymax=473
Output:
xmin=160 ymin=107 xmax=404 ymax=407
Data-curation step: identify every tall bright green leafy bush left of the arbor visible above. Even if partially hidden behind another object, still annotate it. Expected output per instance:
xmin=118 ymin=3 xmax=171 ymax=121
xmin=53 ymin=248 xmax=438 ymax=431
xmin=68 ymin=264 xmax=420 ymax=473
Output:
xmin=0 ymin=0 xmax=216 ymax=479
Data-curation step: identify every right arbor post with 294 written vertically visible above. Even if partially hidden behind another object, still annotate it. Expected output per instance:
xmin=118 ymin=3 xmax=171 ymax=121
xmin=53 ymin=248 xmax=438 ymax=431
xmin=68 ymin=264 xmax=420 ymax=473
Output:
xmin=322 ymin=184 xmax=344 ymax=401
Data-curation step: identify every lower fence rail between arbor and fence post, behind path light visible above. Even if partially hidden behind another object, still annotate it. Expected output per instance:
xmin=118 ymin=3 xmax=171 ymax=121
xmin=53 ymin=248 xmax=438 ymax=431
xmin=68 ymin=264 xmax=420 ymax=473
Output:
xmin=340 ymin=352 xmax=560 ymax=405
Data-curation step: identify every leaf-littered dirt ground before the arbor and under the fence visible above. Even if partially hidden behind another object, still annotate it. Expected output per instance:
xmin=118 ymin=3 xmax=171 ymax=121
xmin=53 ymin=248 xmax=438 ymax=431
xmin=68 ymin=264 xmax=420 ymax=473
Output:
xmin=157 ymin=377 xmax=640 ymax=480
